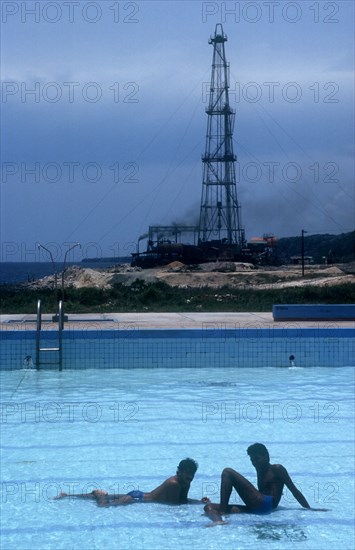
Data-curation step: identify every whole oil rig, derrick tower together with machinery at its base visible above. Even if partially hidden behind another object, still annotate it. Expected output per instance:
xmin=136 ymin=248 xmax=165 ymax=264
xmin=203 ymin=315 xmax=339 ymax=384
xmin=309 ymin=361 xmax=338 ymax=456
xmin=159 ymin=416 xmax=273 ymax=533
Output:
xmin=132 ymin=24 xmax=276 ymax=267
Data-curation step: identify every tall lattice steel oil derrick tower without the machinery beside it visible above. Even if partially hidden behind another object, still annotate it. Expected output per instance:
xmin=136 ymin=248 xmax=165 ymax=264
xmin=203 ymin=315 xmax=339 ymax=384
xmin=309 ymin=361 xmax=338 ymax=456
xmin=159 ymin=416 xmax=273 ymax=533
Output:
xmin=198 ymin=24 xmax=245 ymax=258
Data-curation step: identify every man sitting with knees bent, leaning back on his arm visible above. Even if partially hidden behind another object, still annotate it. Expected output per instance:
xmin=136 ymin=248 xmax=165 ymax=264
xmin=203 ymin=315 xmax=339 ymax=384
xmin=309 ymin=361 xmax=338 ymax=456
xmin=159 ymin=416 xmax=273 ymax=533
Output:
xmin=205 ymin=443 xmax=326 ymax=525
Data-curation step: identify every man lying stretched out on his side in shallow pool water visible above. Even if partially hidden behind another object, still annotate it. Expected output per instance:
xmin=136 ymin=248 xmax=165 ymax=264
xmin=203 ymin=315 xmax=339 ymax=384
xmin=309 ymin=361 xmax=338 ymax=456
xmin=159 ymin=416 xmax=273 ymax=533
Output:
xmin=57 ymin=458 xmax=209 ymax=506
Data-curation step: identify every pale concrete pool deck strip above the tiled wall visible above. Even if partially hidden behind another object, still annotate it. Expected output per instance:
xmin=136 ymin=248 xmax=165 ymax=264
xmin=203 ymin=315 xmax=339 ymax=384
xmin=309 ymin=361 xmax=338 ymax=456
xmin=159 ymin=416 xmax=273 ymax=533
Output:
xmin=0 ymin=312 xmax=355 ymax=331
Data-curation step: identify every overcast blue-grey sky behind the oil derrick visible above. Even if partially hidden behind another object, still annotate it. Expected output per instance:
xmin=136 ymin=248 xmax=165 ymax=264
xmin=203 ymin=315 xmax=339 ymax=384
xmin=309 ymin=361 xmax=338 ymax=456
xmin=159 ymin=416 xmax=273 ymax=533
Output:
xmin=1 ymin=0 xmax=354 ymax=261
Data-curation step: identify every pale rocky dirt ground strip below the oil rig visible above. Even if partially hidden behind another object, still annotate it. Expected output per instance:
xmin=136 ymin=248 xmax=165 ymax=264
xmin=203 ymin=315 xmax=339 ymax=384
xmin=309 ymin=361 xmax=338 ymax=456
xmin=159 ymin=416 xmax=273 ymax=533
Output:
xmin=26 ymin=262 xmax=355 ymax=289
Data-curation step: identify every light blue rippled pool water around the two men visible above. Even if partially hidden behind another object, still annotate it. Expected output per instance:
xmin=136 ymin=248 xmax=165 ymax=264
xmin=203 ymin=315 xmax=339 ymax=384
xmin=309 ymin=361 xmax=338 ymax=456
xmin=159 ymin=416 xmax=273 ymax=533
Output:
xmin=0 ymin=367 xmax=354 ymax=550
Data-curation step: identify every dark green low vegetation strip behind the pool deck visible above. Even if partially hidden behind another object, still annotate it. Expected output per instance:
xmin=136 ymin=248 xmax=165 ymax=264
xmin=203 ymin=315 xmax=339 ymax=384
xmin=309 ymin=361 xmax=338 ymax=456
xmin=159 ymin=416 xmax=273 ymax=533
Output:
xmin=1 ymin=279 xmax=355 ymax=314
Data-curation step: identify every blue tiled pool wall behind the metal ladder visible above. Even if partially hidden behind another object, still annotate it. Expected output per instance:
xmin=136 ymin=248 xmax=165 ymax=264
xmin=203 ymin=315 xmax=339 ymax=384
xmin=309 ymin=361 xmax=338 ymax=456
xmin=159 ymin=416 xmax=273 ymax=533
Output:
xmin=0 ymin=327 xmax=355 ymax=370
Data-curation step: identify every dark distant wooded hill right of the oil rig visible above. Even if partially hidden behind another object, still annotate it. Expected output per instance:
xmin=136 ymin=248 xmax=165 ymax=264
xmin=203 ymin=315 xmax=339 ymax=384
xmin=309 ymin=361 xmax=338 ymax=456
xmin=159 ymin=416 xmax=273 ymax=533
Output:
xmin=277 ymin=231 xmax=355 ymax=263
